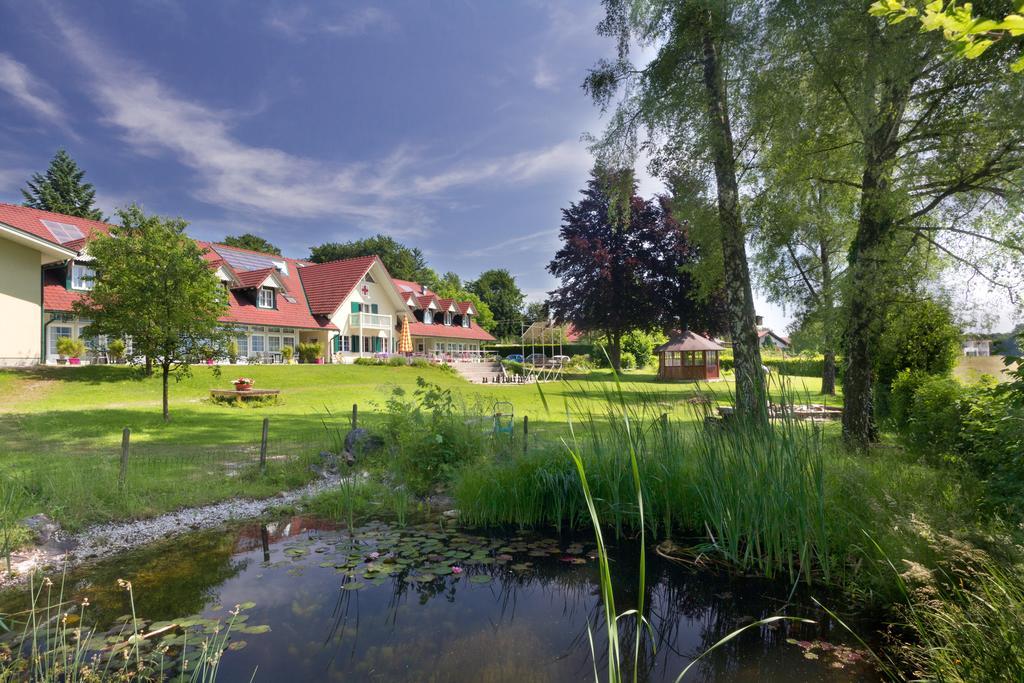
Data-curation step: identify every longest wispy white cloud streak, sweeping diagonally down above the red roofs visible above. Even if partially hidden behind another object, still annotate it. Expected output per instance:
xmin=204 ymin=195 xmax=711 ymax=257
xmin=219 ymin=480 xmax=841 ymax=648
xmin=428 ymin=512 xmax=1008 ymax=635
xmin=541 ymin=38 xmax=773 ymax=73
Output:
xmin=53 ymin=14 xmax=591 ymax=229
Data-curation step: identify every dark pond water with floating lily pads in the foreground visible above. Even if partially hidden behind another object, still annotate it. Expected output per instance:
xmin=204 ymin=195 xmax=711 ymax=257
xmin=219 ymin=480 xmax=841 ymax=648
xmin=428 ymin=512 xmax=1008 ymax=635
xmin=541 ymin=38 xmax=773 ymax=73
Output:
xmin=0 ymin=517 xmax=878 ymax=682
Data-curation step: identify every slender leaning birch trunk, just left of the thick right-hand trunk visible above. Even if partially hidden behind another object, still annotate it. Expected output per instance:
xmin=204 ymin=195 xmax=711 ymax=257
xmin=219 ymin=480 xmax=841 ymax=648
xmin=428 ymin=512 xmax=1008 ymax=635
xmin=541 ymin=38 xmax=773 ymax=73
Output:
xmin=702 ymin=18 xmax=768 ymax=424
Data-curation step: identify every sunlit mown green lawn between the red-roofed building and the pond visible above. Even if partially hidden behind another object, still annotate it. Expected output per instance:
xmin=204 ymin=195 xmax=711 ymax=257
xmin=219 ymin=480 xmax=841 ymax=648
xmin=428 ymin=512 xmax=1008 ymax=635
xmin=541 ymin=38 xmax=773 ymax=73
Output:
xmin=0 ymin=366 xmax=838 ymax=528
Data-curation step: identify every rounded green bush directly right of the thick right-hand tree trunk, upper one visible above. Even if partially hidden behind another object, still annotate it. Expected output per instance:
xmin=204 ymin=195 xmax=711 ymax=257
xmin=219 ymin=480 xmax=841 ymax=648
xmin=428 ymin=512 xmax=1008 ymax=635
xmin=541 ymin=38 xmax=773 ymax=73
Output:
xmin=874 ymin=299 xmax=961 ymax=387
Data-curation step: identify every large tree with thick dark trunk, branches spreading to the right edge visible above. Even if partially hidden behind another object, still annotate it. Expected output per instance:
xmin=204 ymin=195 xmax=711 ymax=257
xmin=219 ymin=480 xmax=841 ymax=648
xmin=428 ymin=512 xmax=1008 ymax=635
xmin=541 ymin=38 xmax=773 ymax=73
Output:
xmin=767 ymin=0 xmax=1024 ymax=447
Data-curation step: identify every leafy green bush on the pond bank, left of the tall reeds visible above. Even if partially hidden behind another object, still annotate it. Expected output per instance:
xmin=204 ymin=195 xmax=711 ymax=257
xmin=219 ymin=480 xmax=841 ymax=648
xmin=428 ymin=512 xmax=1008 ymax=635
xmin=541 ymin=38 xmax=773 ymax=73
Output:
xmin=384 ymin=377 xmax=485 ymax=496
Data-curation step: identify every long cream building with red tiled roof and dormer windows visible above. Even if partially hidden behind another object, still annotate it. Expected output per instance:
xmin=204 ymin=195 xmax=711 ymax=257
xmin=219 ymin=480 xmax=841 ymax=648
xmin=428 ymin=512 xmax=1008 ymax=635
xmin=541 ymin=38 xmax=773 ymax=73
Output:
xmin=0 ymin=203 xmax=494 ymax=365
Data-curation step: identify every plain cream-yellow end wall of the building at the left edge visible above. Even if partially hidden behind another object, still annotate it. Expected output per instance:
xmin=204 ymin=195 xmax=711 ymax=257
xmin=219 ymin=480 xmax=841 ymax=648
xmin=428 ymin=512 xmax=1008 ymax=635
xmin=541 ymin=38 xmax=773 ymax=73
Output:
xmin=0 ymin=238 xmax=42 ymax=366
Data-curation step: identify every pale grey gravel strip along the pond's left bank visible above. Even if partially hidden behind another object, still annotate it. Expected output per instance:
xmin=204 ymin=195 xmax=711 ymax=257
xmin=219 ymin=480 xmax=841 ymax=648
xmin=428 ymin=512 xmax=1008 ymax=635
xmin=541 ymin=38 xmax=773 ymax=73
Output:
xmin=0 ymin=474 xmax=341 ymax=590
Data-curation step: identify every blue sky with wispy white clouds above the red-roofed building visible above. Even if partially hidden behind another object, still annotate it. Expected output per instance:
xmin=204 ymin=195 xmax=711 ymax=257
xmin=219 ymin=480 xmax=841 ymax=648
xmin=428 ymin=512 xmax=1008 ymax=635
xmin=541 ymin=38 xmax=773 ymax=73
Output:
xmin=0 ymin=0 xmax=798 ymax=328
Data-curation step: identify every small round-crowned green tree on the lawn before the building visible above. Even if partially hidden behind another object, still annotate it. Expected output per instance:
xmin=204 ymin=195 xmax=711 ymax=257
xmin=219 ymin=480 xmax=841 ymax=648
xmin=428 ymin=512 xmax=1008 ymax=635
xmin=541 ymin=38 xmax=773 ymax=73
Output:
xmin=74 ymin=205 xmax=231 ymax=421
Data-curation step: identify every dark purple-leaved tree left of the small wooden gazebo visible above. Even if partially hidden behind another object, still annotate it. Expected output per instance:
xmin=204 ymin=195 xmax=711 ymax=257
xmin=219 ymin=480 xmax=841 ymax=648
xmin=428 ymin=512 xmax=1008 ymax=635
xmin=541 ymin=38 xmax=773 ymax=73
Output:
xmin=548 ymin=170 xmax=659 ymax=370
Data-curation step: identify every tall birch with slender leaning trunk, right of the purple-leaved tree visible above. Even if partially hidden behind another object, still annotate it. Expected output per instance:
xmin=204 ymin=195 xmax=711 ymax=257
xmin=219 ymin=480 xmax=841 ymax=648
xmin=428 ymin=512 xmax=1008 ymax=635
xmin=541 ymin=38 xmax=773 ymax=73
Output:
xmin=585 ymin=0 xmax=767 ymax=425
